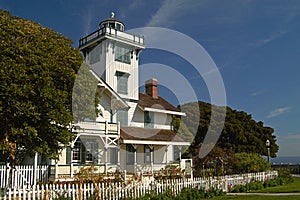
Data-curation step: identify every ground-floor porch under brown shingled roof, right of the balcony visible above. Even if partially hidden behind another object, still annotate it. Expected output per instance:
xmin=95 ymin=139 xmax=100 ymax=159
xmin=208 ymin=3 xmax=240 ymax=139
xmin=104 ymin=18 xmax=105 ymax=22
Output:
xmin=120 ymin=127 xmax=192 ymax=174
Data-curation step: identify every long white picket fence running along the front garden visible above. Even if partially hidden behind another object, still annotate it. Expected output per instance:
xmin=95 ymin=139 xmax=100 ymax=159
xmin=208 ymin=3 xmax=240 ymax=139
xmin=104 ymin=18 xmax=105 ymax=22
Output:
xmin=0 ymin=171 xmax=278 ymax=200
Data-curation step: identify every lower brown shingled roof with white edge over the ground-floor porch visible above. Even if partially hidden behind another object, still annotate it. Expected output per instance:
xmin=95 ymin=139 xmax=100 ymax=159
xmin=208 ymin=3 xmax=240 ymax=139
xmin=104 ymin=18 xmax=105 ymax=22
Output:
xmin=120 ymin=127 xmax=190 ymax=146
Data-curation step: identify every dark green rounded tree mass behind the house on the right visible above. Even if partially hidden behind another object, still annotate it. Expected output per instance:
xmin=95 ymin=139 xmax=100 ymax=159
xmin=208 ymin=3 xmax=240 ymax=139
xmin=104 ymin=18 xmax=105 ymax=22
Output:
xmin=180 ymin=101 xmax=279 ymax=157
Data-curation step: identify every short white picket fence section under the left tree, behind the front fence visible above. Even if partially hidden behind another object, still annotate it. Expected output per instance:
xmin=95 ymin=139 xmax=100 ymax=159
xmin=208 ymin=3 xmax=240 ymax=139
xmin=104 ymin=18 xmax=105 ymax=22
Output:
xmin=0 ymin=165 xmax=48 ymax=189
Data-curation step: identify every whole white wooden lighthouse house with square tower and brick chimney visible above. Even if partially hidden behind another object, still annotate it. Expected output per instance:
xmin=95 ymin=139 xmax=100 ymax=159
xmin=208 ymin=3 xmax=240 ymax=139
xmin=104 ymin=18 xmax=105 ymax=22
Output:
xmin=51 ymin=13 xmax=190 ymax=179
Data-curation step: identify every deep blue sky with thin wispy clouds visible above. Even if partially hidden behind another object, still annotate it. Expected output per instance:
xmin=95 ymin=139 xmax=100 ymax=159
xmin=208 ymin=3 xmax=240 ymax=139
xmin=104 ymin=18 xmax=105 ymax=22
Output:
xmin=0 ymin=0 xmax=300 ymax=156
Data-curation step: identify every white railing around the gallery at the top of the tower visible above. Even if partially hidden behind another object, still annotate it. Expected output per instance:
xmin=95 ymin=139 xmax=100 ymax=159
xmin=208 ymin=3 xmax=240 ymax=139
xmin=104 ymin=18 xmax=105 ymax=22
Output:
xmin=79 ymin=27 xmax=144 ymax=48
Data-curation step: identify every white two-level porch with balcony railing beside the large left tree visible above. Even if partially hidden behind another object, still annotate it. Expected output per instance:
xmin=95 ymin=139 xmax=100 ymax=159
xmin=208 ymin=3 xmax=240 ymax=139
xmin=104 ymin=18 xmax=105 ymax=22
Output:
xmin=49 ymin=122 xmax=120 ymax=181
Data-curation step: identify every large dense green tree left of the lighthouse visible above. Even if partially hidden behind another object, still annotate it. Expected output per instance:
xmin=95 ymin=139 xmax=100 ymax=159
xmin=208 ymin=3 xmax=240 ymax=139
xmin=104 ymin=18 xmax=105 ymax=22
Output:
xmin=0 ymin=10 xmax=82 ymax=162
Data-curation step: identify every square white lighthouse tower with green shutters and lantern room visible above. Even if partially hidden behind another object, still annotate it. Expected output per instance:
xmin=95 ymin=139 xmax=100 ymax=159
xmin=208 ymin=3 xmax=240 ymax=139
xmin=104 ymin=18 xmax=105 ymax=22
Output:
xmin=79 ymin=13 xmax=145 ymax=102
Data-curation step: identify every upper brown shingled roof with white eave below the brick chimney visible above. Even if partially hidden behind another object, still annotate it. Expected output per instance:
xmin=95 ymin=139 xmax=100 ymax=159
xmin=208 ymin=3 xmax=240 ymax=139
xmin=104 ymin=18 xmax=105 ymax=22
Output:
xmin=138 ymin=93 xmax=185 ymax=115
